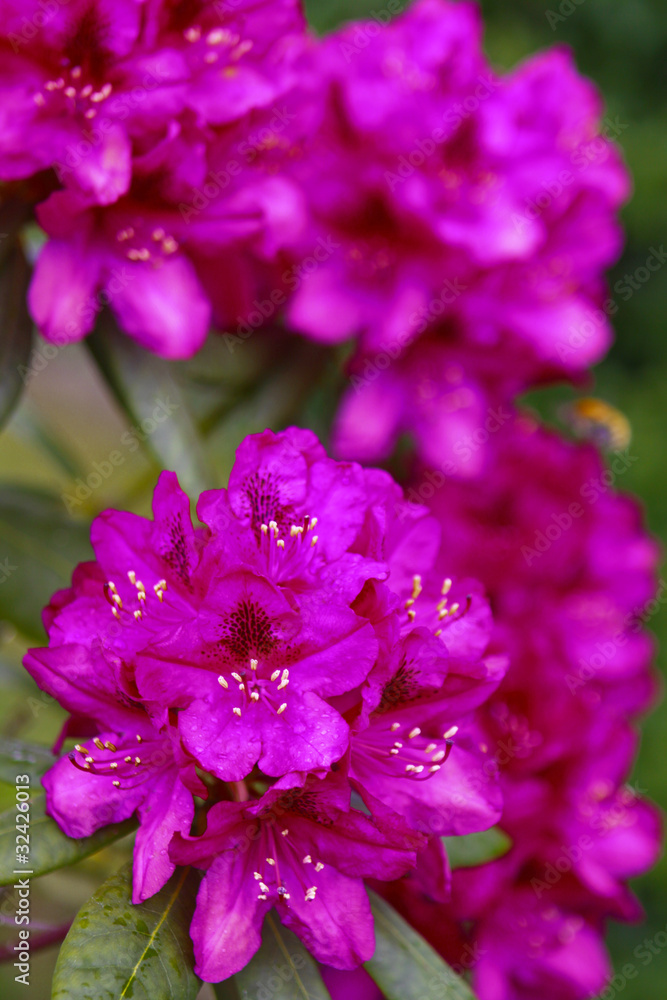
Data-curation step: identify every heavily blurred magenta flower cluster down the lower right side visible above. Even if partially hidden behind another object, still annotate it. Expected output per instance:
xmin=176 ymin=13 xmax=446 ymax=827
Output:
xmin=394 ymin=413 xmax=661 ymax=1000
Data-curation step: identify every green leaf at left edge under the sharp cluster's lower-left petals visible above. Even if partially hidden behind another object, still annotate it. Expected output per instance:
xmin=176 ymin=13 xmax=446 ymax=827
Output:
xmin=0 ymin=788 xmax=136 ymax=885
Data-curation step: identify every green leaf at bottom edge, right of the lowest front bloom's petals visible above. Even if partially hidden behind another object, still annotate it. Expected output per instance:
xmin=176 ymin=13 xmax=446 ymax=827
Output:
xmin=365 ymin=892 xmax=475 ymax=1000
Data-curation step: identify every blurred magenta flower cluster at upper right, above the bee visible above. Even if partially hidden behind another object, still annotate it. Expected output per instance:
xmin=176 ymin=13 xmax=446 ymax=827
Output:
xmin=276 ymin=0 xmax=629 ymax=468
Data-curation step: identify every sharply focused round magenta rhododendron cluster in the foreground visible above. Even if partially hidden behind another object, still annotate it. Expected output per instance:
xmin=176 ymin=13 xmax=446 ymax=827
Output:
xmin=26 ymin=429 xmax=506 ymax=982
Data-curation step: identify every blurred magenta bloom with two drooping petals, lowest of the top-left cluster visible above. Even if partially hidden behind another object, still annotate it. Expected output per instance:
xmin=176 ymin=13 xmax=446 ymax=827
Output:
xmin=29 ymin=127 xmax=304 ymax=358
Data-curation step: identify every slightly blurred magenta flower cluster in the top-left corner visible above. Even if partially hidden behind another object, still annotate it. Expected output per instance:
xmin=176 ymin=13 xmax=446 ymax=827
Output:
xmin=0 ymin=0 xmax=304 ymax=358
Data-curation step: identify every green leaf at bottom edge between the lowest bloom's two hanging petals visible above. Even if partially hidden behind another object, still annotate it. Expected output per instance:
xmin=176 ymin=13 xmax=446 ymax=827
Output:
xmin=234 ymin=911 xmax=331 ymax=1000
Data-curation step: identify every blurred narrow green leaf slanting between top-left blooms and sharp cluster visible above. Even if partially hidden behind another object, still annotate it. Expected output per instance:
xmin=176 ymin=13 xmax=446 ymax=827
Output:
xmin=87 ymin=317 xmax=217 ymax=497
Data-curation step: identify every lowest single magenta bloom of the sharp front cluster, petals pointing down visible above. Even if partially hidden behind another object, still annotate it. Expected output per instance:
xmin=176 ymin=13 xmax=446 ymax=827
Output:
xmin=171 ymin=775 xmax=422 ymax=982
